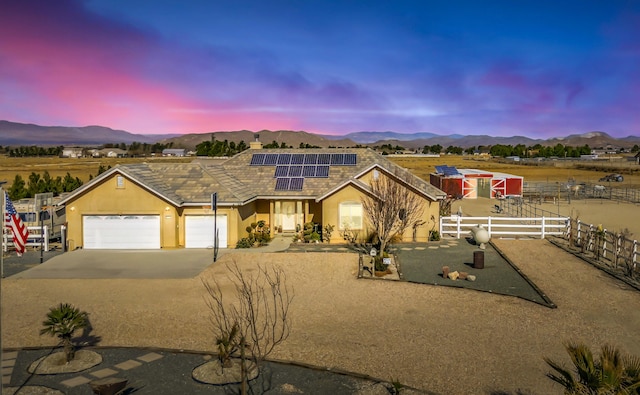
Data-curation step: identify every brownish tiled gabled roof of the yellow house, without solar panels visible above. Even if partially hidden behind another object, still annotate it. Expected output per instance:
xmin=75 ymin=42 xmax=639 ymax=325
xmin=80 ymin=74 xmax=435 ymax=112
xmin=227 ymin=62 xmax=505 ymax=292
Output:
xmin=60 ymin=148 xmax=446 ymax=206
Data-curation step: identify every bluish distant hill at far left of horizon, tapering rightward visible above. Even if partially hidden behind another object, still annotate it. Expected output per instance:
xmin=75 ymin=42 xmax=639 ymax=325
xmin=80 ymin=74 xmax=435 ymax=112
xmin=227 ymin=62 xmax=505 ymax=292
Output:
xmin=0 ymin=121 xmax=176 ymax=146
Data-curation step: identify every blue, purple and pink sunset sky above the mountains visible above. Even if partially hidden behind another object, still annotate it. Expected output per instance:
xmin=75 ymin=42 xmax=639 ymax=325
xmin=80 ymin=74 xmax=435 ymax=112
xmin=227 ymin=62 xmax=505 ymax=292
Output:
xmin=0 ymin=0 xmax=640 ymax=138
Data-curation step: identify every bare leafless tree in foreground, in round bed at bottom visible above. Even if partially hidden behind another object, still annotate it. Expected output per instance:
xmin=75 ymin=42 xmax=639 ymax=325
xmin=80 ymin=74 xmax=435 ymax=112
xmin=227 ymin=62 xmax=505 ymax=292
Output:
xmin=203 ymin=261 xmax=293 ymax=394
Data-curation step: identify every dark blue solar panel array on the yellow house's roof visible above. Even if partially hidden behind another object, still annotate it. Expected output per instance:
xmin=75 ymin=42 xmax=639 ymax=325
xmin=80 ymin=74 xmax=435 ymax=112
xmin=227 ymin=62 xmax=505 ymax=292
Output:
xmin=250 ymin=153 xmax=357 ymax=191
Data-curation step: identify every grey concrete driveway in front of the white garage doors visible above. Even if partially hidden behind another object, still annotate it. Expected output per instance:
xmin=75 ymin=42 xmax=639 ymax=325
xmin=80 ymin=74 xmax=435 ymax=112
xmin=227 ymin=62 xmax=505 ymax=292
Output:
xmin=10 ymin=249 xmax=223 ymax=279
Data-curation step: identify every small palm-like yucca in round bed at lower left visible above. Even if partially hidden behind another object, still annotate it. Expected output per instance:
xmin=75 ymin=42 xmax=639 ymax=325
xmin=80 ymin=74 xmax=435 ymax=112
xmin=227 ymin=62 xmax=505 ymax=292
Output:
xmin=40 ymin=303 xmax=89 ymax=363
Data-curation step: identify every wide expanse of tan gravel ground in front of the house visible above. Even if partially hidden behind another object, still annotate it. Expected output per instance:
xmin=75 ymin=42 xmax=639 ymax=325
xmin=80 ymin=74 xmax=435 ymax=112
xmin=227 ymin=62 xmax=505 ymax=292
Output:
xmin=2 ymin=244 xmax=640 ymax=394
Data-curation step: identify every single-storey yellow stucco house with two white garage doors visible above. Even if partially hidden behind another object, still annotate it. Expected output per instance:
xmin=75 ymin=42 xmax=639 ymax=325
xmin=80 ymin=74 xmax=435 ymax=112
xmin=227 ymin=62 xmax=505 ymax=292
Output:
xmin=60 ymin=142 xmax=446 ymax=249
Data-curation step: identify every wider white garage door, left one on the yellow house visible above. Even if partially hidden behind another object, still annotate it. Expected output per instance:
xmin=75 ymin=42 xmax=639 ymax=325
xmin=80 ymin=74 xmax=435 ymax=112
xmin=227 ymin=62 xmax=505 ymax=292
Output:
xmin=82 ymin=215 xmax=160 ymax=250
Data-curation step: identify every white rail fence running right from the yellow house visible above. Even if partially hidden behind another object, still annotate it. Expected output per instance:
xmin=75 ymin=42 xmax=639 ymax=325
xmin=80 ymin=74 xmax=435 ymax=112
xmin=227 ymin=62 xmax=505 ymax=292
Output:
xmin=440 ymin=215 xmax=569 ymax=239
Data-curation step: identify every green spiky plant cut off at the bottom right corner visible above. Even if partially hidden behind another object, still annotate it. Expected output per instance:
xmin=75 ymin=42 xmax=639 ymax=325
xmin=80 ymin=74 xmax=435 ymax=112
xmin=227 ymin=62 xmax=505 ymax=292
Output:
xmin=544 ymin=343 xmax=640 ymax=395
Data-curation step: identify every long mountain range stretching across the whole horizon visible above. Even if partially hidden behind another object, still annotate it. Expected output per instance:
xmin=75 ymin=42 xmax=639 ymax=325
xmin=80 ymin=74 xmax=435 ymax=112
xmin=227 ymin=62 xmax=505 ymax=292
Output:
xmin=0 ymin=120 xmax=640 ymax=149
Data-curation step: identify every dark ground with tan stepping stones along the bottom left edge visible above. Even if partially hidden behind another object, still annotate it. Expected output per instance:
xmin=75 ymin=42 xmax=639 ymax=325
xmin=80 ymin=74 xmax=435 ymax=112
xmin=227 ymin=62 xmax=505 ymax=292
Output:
xmin=2 ymin=348 xmax=412 ymax=395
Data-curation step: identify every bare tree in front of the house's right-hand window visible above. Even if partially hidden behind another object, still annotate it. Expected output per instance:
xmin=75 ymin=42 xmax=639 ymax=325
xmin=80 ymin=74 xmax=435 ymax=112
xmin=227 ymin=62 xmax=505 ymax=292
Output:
xmin=362 ymin=169 xmax=424 ymax=256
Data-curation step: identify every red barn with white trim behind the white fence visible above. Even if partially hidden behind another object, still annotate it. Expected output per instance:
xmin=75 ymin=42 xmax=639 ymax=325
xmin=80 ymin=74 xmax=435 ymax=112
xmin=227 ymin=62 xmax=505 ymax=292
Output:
xmin=429 ymin=166 xmax=524 ymax=199
